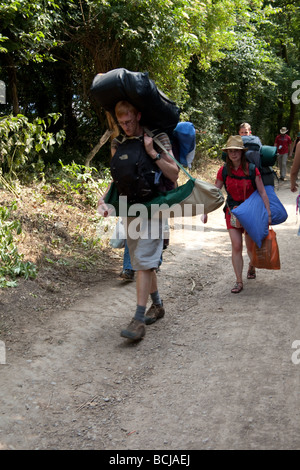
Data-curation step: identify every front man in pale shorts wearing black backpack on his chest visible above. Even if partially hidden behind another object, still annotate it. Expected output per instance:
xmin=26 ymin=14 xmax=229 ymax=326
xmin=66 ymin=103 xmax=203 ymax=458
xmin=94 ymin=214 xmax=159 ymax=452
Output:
xmin=98 ymin=101 xmax=178 ymax=341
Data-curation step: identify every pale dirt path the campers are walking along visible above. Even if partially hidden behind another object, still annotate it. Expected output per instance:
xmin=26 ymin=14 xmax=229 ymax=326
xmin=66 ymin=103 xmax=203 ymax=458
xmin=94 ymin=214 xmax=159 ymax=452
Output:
xmin=0 ymin=178 xmax=300 ymax=450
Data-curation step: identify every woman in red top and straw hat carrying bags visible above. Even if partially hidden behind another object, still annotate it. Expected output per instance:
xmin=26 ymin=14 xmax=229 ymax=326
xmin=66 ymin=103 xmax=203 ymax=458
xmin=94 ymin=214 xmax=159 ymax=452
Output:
xmin=215 ymin=135 xmax=271 ymax=294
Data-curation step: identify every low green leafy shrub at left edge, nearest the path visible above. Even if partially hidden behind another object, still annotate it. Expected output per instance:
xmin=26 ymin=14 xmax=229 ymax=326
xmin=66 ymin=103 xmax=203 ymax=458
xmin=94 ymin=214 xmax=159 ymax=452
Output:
xmin=0 ymin=203 xmax=36 ymax=288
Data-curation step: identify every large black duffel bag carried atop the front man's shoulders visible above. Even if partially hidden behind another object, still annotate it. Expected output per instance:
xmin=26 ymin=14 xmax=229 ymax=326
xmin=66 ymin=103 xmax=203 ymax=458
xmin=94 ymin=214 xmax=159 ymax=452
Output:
xmin=91 ymin=68 xmax=180 ymax=132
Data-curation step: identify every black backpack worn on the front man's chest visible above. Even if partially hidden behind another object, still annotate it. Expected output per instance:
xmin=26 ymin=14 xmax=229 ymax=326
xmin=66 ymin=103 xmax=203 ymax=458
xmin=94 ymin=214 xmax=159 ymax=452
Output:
xmin=110 ymin=137 xmax=161 ymax=204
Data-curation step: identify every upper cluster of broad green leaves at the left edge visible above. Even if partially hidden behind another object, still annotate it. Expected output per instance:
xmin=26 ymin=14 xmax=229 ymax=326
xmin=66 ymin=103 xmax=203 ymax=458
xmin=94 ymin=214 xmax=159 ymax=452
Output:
xmin=0 ymin=114 xmax=65 ymax=178
